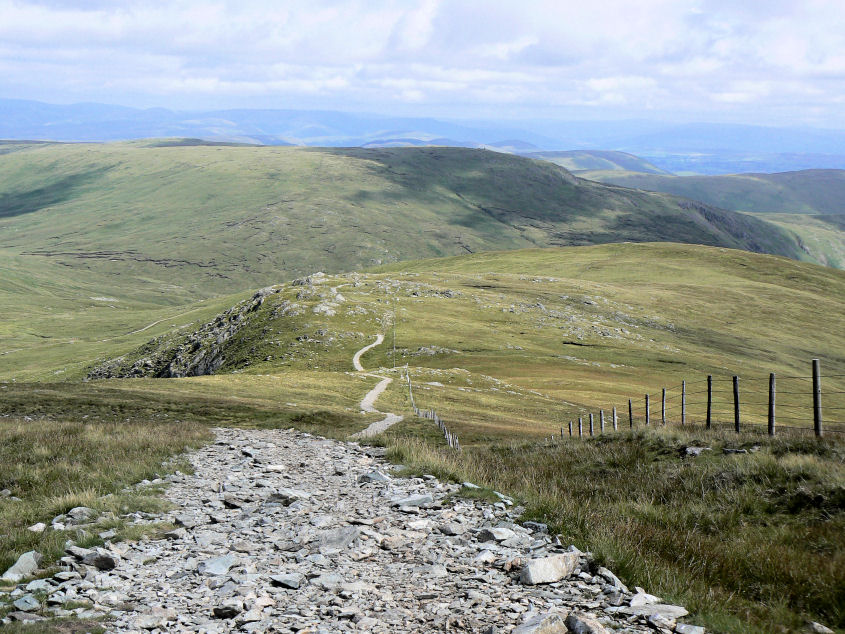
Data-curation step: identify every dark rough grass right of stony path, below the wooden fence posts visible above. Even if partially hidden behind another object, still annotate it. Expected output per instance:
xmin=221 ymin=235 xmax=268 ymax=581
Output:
xmin=386 ymin=430 xmax=845 ymax=633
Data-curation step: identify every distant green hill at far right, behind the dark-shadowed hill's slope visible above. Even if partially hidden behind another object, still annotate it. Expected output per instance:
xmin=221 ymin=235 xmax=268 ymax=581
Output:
xmin=582 ymin=168 xmax=845 ymax=214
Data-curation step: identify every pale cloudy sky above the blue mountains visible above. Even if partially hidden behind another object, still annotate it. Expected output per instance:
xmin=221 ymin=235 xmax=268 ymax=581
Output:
xmin=0 ymin=0 xmax=845 ymax=129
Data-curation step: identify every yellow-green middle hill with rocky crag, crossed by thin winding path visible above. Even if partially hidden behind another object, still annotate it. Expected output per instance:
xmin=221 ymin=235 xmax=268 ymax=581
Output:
xmin=74 ymin=244 xmax=845 ymax=434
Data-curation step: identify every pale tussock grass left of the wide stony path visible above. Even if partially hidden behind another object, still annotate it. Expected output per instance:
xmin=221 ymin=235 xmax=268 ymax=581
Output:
xmin=0 ymin=416 xmax=210 ymax=570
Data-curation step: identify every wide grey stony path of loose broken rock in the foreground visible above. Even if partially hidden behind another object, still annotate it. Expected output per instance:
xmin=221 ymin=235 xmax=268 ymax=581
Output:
xmin=1 ymin=429 xmax=703 ymax=634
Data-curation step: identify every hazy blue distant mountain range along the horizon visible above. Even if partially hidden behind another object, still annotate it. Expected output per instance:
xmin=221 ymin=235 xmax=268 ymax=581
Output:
xmin=0 ymin=99 xmax=845 ymax=174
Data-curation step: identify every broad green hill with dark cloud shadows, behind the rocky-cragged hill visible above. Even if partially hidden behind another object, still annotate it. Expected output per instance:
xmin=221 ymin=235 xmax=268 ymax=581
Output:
xmin=0 ymin=141 xmax=806 ymax=301
